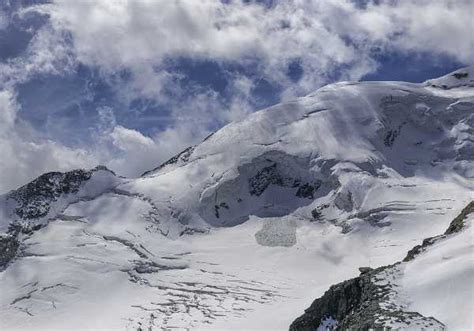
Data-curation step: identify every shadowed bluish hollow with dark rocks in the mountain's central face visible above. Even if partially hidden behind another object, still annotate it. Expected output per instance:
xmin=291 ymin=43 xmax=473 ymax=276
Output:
xmin=200 ymin=151 xmax=340 ymax=226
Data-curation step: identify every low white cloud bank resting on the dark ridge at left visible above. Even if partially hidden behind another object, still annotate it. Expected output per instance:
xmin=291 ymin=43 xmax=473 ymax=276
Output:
xmin=0 ymin=90 xmax=189 ymax=194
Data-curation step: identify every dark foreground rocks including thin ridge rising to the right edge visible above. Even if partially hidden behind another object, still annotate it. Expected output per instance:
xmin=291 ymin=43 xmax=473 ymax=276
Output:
xmin=290 ymin=201 xmax=474 ymax=331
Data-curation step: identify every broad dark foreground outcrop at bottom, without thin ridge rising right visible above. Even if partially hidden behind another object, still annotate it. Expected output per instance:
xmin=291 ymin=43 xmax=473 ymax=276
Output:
xmin=290 ymin=264 xmax=443 ymax=331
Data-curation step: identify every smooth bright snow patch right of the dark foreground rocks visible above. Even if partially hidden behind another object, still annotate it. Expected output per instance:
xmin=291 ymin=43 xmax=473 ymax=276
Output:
xmin=398 ymin=213 xmax=474 ymax=330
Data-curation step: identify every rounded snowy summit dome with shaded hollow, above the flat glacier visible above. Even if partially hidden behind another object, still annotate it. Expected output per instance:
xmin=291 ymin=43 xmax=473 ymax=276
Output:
xmin=126 ymin=68 xmax=474 ymax=232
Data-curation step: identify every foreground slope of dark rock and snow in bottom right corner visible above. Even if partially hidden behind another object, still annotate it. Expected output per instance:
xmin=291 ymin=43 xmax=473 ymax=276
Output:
xmin=290 ymin=201 xmax=474 ymax=331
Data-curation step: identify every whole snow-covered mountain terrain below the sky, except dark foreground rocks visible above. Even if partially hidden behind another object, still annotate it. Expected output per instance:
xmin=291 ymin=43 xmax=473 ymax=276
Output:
xmin=0 ymin=67 xmax=474 ymax=330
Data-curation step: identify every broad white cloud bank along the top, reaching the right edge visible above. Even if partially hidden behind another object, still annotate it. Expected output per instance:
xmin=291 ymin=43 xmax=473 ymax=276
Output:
xmin=42 ymin=0 xmax=474 ymax=94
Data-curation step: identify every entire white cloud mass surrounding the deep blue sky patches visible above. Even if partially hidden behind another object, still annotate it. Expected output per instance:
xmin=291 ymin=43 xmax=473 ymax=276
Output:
xmin=0 ymin=0 xmax=474 ymax=192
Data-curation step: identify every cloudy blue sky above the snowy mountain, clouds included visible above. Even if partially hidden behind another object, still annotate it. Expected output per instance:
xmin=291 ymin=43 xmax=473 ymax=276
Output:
xmin=0 ymin=0 xmax=474 ymax=192
